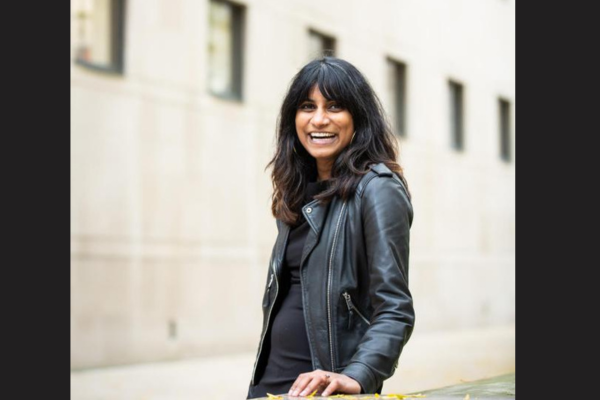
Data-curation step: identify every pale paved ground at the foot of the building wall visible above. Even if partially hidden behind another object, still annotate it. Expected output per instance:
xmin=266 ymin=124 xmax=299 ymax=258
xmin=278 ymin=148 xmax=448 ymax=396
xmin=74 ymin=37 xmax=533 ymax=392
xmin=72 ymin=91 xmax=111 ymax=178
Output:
xmin=71 ymin=326 xmax=515 ymax=400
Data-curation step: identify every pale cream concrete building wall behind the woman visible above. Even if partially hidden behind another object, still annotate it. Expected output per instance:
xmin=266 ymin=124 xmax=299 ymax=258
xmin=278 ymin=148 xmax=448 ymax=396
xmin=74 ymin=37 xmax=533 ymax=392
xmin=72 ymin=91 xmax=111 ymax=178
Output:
xmin=71 ymin=0 xmax=516 ymax=368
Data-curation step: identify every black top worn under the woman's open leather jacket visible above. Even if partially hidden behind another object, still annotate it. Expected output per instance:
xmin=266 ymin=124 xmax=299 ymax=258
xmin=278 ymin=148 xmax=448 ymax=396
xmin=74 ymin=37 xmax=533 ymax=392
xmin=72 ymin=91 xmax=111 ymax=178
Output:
xmin=248 ymin=181 xmax=327 ymax=398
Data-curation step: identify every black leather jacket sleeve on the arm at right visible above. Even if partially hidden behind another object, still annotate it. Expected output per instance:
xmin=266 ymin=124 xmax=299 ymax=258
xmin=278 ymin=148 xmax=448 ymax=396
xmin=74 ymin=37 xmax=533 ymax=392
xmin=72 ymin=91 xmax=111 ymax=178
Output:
xmin=342 ymin=176 xmax=415 ymax=393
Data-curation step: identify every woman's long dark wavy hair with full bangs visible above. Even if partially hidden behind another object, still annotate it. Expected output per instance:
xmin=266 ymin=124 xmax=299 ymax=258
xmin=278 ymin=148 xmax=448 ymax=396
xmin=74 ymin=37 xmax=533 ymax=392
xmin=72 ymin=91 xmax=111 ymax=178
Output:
xmin=266 ymin=56 xmax=407 ymax=225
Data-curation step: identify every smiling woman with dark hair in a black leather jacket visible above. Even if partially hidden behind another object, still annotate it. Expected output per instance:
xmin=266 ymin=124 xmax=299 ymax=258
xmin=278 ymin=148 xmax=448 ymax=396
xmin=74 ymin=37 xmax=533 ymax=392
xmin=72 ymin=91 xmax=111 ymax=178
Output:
xmin=248 ymin=57 xmax=415 ymax=398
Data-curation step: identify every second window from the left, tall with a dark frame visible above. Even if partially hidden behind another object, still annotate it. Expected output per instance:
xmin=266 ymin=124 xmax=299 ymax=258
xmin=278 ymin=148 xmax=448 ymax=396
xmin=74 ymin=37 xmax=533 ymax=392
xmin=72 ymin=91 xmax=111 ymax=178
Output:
xmin=208 ymin=0 xmax=245 ymax=100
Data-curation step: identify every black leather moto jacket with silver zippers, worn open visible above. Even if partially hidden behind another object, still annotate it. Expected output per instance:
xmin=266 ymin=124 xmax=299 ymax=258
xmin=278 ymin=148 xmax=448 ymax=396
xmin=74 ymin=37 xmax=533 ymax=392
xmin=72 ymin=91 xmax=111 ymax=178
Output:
xmin=250 ymin=163 xmax=415 ymax=393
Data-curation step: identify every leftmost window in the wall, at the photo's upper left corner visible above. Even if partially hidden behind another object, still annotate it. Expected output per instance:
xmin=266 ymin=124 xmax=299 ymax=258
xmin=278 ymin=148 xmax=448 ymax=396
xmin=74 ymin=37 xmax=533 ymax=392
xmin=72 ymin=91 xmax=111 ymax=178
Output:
xmin=72 ymin=0 xmax=125 ymax=74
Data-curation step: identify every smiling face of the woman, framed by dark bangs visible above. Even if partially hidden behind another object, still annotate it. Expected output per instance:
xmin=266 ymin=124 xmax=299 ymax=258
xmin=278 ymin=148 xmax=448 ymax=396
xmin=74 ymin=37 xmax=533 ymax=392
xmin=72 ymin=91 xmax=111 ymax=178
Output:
xmin=296 ymin=85 xmax=354 ymax=168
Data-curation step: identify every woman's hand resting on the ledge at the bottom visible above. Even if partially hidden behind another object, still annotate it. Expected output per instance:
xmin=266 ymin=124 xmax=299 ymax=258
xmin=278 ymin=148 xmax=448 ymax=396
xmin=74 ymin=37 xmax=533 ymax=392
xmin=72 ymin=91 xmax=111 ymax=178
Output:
xmin=288 ymin=369 xmax=361 ymax=396
